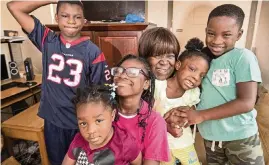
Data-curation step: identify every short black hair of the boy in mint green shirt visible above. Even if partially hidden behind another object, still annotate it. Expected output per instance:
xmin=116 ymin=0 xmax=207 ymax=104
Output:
xmin=207 ymin=4 xmax=245 ymax=29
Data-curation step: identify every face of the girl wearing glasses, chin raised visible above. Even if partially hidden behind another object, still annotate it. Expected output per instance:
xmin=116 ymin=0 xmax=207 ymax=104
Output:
xmin=114 ymin=59 xmax=149 ymax=97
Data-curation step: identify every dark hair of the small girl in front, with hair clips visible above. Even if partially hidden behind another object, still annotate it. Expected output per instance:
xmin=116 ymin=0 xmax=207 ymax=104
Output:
xmin=72 ymin=84 xmax=118 ymax=117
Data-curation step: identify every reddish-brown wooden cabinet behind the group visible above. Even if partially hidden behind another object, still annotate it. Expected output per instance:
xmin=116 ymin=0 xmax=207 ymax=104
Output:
xmin=46 ymin=23 xmax=156 ymax=67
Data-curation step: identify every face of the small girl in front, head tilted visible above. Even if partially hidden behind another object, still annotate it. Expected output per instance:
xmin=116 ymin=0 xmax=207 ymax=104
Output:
xmin=77 ymin=103 xmax=115 ymax=149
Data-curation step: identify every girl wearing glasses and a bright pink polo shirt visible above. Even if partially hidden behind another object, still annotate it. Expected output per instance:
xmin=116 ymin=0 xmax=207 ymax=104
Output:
xmin=111 ymin=55 xmax=169 ymax=165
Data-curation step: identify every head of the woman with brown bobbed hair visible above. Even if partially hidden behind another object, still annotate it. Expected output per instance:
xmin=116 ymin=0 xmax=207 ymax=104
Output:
xmin=138 ymin=27 xmax=180 ymax=80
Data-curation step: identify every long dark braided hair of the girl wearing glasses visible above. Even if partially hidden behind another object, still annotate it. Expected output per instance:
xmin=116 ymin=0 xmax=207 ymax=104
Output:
xmin=116 ymin=54 xmax=155 ymax=142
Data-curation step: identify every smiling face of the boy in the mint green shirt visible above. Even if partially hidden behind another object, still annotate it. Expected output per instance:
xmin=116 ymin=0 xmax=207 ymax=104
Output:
xmin=206 ymin=16 xmax=243 ymax=56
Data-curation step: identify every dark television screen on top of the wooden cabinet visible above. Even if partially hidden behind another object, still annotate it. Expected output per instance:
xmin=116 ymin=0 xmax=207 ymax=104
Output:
xmin=82 ymin=1 xmax=145 ymax=21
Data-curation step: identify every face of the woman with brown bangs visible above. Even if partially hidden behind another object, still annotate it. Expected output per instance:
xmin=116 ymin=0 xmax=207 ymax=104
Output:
xmin=148 ymin=53 xmax=176 ymax=80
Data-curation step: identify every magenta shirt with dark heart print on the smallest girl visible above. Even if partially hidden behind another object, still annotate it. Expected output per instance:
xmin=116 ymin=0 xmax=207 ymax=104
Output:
xmin=67 ymin=126 xmax=140 ymax=165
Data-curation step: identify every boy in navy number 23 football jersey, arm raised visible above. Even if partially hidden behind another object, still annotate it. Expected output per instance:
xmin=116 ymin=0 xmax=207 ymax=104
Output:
xmin=7 ymin=1 xmax=109 ymax=165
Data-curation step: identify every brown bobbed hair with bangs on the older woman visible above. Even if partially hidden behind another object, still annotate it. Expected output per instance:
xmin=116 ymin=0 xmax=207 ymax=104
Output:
xmin=138 ymin=27 xmax=180 ymax=60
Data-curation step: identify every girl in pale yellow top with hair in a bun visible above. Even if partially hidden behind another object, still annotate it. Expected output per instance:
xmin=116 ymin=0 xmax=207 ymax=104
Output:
xmin=154 ymin=38 xmax=210 ymax=165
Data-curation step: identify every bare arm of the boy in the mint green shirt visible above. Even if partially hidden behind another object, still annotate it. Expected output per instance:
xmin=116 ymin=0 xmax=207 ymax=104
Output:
xmin=180 ymin=82 xmax=258 ymax=124
